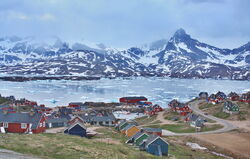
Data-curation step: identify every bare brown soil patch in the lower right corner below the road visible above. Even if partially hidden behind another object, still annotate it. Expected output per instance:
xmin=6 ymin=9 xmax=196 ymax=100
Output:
xmin=194 ymin=132 xmax=250 ymax=159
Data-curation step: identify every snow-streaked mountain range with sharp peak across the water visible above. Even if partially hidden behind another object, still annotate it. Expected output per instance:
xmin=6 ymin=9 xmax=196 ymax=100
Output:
xmin=0 ymin=29 xmax=250 ymax=80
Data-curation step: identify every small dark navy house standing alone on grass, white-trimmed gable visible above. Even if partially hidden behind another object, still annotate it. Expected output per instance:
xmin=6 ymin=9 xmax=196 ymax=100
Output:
xmin=64 ymin=122 xmax=87 ymax=137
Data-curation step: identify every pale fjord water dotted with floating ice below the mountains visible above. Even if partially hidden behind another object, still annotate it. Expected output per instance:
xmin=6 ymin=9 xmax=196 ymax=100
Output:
xmin=0 ymin=78 xmax=250 ymax=107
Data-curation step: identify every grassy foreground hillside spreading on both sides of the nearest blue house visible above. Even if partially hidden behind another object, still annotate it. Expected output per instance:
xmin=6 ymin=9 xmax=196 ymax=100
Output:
xmin=0 ymin=128 xmax=225 ymax=159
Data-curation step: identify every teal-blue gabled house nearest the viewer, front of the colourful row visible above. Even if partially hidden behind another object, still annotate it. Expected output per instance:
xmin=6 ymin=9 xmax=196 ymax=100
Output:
xmin=140 ymin=135 xmax=169 ymax=156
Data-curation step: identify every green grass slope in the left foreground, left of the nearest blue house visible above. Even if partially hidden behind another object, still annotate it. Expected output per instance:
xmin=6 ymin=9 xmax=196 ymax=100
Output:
xmin=0 ymin=130 xmax=162 ymax=159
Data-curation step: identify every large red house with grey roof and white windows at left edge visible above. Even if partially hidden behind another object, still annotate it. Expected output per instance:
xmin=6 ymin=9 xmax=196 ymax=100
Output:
xmin=0 ymin=111 xmax=46 ymax=133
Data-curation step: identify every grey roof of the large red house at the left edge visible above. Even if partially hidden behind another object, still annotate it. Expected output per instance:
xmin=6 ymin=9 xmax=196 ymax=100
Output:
xmin=0 ymin=110 xmax=43 ymax=129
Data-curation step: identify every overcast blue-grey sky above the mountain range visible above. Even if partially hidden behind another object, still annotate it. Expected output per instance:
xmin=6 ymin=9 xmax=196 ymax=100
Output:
xmin=0 ymin=0 xmax=250 ymax=48
